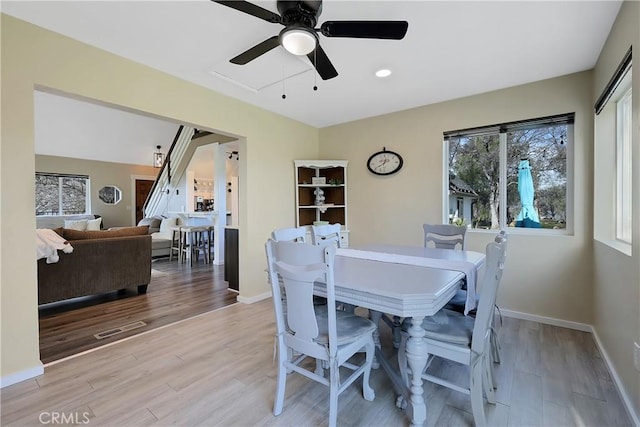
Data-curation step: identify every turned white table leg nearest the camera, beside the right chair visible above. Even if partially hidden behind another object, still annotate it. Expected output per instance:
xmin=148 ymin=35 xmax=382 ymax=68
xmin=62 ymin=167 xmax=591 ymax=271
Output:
xmin=406 ymin=317 xmax=428 ymax=426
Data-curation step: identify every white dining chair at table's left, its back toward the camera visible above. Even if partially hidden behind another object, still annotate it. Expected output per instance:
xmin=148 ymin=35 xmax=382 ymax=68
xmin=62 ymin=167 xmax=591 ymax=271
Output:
xmin=266 ymin=239 xmax=376 ymax=427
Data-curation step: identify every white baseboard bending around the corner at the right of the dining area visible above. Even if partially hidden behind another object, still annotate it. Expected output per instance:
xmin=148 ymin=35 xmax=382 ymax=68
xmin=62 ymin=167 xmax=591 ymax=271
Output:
xmin=500 ymin=309 xmax=640 ymax=426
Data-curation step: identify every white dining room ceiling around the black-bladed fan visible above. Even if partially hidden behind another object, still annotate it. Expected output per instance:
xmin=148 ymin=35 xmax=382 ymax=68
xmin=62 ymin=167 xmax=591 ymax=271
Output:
xmin=1 ymin=0 xmax=621 ymax=129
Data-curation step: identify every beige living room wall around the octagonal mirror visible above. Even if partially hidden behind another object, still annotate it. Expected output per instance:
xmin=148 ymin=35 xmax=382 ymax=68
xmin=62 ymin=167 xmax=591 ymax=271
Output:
xmin=35 ymin=155 xmax=158 ymax=228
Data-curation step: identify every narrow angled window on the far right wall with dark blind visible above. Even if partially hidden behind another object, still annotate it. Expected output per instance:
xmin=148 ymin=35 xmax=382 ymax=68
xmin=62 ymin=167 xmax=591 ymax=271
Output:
xmin=593 ymin=48 xmax=633 ymax=255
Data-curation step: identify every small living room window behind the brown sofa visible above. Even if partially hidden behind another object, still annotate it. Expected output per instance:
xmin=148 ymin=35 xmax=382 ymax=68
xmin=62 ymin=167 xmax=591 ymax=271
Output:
xmin=36 ymin=172 xmax=91 ymax=215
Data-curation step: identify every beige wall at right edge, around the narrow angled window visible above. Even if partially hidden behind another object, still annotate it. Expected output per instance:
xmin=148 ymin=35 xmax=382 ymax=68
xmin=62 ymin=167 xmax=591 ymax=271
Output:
xmin=592 ymin=1 xmax=640 ymax=420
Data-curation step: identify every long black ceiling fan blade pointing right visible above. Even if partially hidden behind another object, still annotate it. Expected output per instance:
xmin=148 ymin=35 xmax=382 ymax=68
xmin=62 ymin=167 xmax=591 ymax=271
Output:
xmin=320 ymin=21 xmax=409 ymax=40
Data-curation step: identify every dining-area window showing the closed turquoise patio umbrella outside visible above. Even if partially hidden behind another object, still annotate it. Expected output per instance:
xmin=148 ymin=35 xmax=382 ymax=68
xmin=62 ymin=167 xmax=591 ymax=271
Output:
xmin=444 ymin=113 xmax=574 ymax=230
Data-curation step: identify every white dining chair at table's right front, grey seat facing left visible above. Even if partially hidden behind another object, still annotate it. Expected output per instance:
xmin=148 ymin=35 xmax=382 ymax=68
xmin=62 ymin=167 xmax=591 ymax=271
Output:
xmin=398 ymin=239 xmax=507 ymax=426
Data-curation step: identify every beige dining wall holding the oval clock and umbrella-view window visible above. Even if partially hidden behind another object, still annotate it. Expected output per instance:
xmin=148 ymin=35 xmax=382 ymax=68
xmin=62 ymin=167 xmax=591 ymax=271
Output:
xmin=320 ymin=72 xmax=593 ymax=324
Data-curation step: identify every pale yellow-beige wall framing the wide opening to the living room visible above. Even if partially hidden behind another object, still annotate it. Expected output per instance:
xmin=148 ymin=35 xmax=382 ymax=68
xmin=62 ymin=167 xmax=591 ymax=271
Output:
xmin=0 ymin=15 xmax=318 ymax=378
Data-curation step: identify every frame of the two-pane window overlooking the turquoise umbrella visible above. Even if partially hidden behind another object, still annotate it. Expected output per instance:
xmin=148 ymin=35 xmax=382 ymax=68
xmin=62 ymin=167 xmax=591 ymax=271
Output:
xmin=442 ymin=112 xmax=575 ymax=236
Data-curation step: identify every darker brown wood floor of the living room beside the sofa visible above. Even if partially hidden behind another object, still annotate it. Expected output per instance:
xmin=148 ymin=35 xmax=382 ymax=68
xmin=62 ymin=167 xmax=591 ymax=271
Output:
xmin=39 ymin=257 xmax=238 ymax=363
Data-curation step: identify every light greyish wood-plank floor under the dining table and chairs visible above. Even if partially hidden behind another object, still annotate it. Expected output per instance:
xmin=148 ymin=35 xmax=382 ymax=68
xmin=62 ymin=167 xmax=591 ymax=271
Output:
xmin=1 ymin=300 xmax=632 ymax=426
